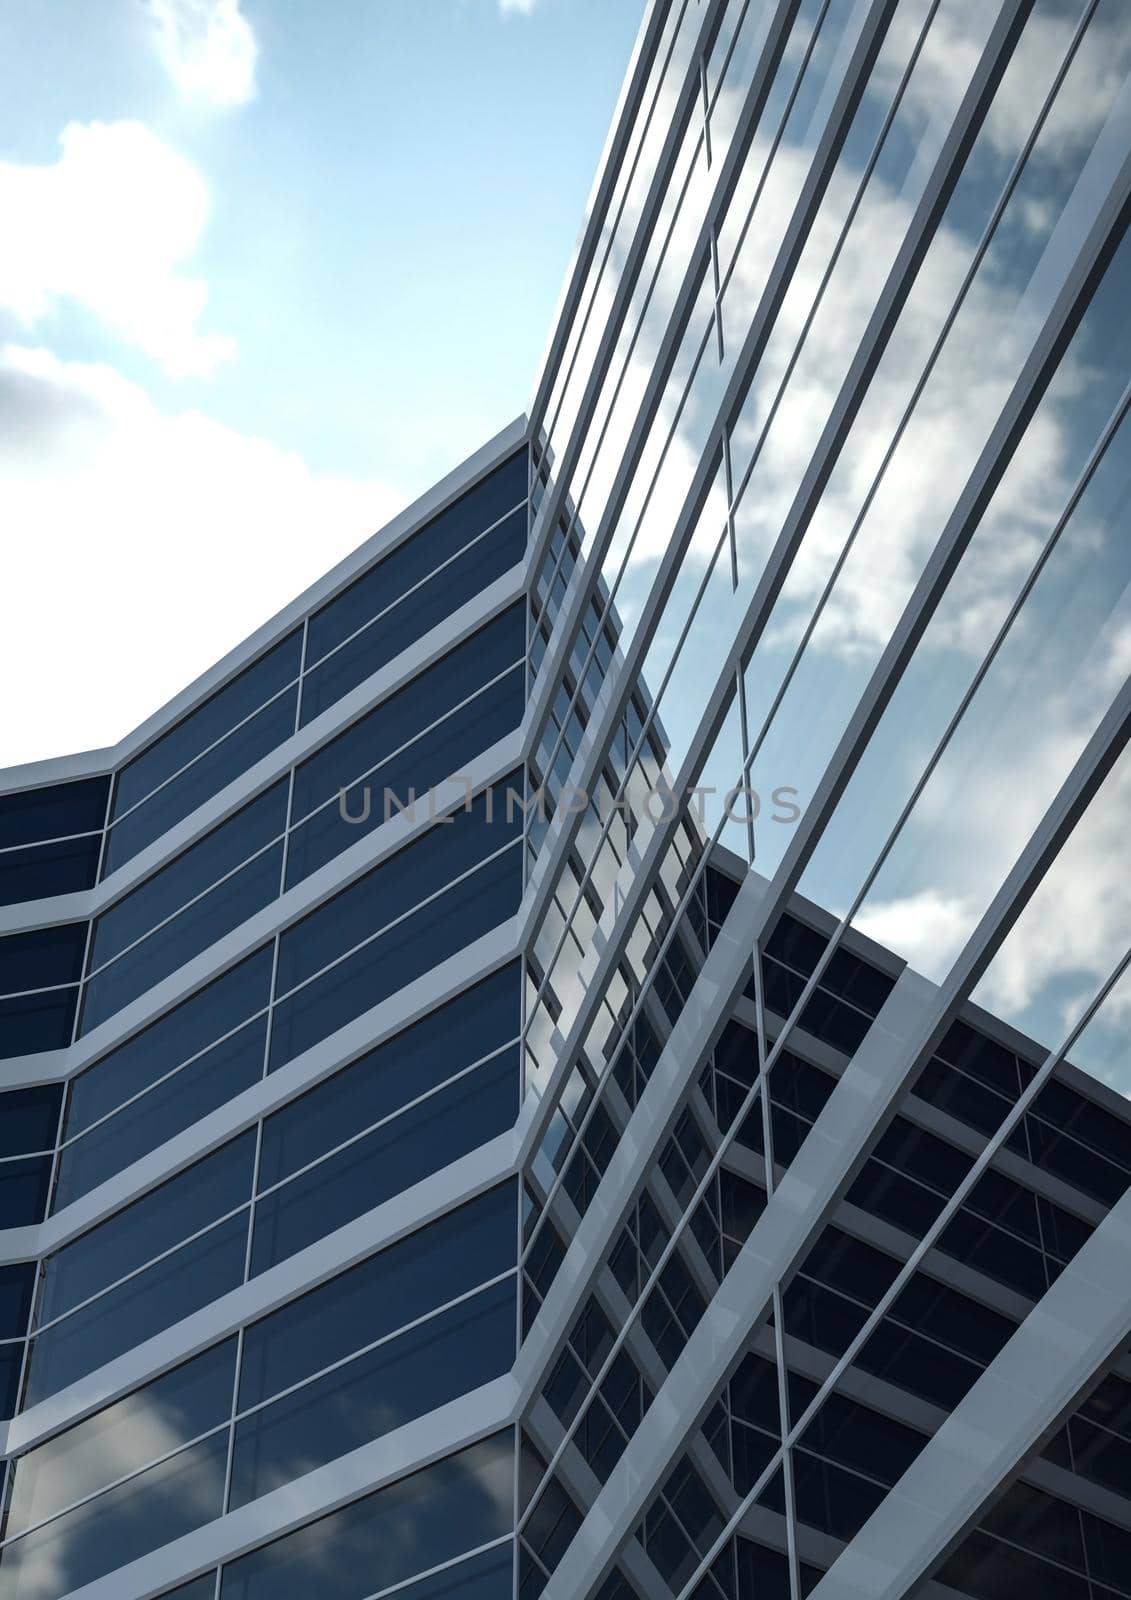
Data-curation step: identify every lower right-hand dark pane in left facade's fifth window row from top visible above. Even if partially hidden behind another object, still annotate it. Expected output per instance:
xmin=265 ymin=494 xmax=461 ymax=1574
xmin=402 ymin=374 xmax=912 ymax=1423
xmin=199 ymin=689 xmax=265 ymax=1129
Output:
xmin=230 ymin=1278 xmax=515 ymax=1507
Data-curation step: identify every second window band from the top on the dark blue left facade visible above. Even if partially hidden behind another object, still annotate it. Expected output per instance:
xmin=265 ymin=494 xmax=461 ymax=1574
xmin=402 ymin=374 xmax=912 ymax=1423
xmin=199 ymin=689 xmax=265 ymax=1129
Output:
xmin=0 ymin=605 xmax=525 ymax=1054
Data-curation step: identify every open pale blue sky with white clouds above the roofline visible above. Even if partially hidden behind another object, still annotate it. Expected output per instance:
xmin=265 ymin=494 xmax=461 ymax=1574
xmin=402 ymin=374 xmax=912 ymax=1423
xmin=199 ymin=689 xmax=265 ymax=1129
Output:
xmin=0 ymin=0 xmax=643 ymax=765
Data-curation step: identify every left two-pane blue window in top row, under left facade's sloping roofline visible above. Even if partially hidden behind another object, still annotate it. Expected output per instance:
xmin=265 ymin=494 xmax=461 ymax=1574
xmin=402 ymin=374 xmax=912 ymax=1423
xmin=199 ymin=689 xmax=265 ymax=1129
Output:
xmin=104 ymin=629 xmax=302 ymax=874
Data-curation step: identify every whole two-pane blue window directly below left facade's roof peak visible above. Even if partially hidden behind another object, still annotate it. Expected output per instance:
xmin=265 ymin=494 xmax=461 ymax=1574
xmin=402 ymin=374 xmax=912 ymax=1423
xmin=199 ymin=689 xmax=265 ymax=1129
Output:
xmin=302 ymin=450 xmax=528 ymax=723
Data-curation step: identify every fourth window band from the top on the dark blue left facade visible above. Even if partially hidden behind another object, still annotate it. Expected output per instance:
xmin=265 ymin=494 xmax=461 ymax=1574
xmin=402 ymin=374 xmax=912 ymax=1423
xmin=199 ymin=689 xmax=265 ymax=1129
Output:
xmin=0 ymin=962 xmax=520 ymax=1414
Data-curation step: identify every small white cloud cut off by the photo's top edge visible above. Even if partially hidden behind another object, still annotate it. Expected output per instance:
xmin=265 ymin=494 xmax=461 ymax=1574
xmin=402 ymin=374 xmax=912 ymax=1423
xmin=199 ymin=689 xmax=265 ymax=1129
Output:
xmin=149 ymin=0 xmax=256 ymax=106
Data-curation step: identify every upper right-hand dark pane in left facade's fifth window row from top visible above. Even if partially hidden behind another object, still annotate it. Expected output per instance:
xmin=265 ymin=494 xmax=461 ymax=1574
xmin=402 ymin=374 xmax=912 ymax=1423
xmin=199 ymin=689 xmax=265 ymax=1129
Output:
xmin=240 ymin=1182 xmax=517 ymax=1410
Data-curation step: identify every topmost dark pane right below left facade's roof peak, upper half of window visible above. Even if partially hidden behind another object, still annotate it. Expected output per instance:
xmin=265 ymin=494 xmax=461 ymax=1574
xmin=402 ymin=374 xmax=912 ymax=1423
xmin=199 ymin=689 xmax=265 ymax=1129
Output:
xmin=307 ymin=450 xmax=528 ymax=666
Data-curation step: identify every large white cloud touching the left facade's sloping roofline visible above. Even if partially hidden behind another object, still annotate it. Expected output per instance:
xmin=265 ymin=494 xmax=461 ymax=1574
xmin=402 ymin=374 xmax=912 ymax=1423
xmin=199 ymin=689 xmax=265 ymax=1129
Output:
xmin=0 ymin=346 xmax=403 ymax=765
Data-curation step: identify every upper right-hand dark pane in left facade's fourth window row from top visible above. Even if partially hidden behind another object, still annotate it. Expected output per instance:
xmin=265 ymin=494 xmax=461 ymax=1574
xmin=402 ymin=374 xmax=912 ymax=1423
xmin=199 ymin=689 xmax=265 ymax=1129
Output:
xmin=259 ymin=962 xmax=520 ymax=1189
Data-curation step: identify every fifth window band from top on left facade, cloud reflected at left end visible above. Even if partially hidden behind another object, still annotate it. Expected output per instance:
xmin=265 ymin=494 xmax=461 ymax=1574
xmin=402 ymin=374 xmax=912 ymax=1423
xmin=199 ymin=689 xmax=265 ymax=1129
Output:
xmin=0 ymin=1181 xmax=517 ymax=1597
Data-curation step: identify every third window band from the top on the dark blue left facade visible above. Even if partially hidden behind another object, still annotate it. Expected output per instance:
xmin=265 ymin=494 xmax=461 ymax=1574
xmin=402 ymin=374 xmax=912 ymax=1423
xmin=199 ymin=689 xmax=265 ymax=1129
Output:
xmin=5 ymin=774 xmax=522 ymax=1227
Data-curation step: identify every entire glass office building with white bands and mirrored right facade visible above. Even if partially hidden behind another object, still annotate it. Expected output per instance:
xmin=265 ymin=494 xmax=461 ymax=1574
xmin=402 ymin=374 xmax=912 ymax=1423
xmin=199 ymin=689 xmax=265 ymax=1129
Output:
xmin=0 ymin=0 xmax=1131 ymax=1600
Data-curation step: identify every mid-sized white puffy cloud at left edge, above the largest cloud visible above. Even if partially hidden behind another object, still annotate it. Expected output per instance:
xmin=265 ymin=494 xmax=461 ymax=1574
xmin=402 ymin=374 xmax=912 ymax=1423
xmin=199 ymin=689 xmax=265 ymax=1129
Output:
xmin=0 ymin=122 xmax=234 ymax=376
